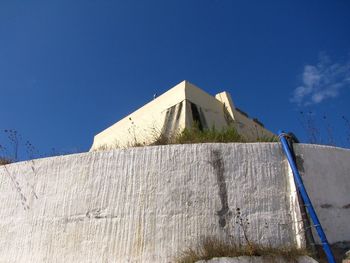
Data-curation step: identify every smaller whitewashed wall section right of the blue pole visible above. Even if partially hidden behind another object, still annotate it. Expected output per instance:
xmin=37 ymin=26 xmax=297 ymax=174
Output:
xmin=295 ymin=144 xmax=350 ymax=243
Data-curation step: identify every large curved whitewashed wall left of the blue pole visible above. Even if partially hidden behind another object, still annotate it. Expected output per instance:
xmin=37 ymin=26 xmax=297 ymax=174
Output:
xmin=0 ymin=143 xmax=303 ymax=263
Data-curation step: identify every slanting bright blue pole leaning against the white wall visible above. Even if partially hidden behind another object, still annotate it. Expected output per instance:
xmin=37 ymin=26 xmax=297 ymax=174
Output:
xmin=278 ymin=131 xmax=335 ymax=263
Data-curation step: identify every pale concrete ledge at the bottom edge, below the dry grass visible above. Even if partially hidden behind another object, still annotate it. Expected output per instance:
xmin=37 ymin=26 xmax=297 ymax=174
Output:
xmin=196 ymin=256 xmax=317 ymax=263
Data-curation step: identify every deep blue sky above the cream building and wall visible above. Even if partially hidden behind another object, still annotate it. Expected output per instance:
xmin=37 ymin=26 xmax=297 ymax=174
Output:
xmin=0 ymin=0 xmax=350 ymax=158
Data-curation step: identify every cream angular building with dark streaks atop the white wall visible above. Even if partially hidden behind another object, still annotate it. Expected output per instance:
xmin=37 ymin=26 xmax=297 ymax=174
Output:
xmin=90 ymin=81 xmax=274 ymax=151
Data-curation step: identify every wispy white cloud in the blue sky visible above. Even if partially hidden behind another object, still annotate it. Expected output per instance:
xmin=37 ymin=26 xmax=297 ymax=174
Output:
xmin=290 ymin=54 xmax=350 ymax=105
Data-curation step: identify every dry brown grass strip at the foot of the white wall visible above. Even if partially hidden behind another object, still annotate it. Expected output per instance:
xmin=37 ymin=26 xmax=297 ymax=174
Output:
xmin=176 ymin=238 xmax=309 ymax=263
